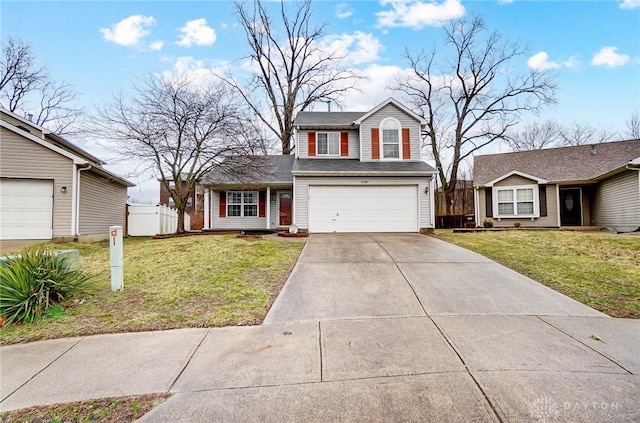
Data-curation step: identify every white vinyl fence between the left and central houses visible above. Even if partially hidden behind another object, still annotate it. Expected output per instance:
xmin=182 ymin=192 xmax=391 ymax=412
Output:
xmin=127 ymin=204 xmax=191 ymax=236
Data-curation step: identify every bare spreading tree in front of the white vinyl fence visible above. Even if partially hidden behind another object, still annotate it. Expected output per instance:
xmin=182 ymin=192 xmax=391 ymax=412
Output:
xmin=96 ymin=75 xmax=264 ymax=232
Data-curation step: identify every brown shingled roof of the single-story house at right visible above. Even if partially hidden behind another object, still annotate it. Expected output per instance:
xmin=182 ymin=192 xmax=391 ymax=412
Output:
xmin=473 ymin=139 xmax=640 ymax=186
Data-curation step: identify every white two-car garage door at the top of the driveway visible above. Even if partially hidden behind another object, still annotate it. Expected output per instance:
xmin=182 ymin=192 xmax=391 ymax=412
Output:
xmin=309 ymin=185 xmax=418 ymax=233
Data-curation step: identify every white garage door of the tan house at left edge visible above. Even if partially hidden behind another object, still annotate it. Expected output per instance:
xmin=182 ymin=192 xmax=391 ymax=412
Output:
xmin=0 ymin=179 xmax=53 ymax=240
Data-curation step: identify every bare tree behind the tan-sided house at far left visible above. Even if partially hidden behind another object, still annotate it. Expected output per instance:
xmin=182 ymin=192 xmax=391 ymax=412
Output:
xmin=0 ymin=37 xmax=82 ymax=135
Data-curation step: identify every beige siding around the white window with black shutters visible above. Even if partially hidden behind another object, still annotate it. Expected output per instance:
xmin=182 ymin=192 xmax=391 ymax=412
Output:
xmin=476 ymin=184 xmax=558 ymax=228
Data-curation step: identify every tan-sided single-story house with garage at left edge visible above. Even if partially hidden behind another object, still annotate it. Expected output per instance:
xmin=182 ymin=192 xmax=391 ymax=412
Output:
xmin=0 ymin=109 xmax=134 ymax=241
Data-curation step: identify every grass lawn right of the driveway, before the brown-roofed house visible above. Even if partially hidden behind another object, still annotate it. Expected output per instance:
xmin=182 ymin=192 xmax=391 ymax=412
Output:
xmin=435 ymin=230 xmax=640 ymax=319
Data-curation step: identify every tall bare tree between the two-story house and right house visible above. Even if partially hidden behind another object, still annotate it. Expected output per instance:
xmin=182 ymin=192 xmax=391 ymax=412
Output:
xmin=397 ymin=17 xmax=555 ymax=214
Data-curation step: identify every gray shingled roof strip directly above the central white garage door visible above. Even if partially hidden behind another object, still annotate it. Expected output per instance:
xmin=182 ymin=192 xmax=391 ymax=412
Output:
xmin=292 ymin=159 xmax=436 ymax=176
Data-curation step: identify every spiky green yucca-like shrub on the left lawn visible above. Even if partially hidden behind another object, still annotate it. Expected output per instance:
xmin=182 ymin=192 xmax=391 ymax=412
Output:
xmin=0 ymin=249 xmax=92 ymax=324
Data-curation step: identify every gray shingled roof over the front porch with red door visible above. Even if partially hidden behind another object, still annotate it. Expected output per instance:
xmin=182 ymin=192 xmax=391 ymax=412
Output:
xmin=201 ymin=155 xmax=294 ymax=185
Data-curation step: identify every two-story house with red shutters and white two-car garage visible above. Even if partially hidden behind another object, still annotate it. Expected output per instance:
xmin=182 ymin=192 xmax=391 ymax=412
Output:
xmin=203 ymin=99 xmax=435 ymax=233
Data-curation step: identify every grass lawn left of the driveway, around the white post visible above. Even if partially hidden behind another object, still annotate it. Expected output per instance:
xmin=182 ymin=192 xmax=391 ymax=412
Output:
xmin=0 ymin=235 xmax=303 ymax=344
